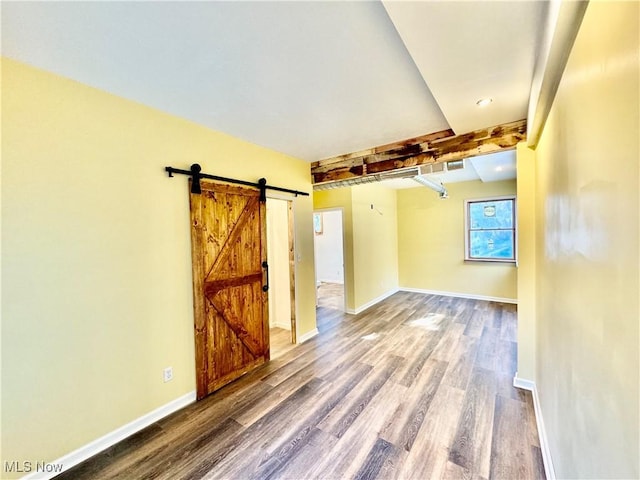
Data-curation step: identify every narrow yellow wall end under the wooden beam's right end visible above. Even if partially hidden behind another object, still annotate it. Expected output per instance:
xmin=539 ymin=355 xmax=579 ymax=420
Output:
xmin=517 ymin=142 xmax=536 ymax=382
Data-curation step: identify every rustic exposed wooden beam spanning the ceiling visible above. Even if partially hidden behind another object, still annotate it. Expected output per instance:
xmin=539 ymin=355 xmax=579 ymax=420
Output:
xmin=311 ymin=120 xmax=527 ymax=184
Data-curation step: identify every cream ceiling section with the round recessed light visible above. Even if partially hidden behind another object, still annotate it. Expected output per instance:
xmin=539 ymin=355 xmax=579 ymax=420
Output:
xmin=383 ymin=1 xmax=547 ymax=134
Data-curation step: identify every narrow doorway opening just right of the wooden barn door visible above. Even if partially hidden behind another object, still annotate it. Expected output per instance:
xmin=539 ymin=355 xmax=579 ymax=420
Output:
xmin=267 ymin=197 xmax=296 ymax=360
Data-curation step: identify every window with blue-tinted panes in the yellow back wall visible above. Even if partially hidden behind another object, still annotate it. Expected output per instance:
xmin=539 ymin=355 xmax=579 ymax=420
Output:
xmin=465 ymin=197 xmax=516 ymax=262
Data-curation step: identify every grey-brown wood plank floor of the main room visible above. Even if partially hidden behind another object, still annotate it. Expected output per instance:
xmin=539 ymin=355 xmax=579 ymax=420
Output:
xmin=59 ymin=292 xmax=544 ymax=480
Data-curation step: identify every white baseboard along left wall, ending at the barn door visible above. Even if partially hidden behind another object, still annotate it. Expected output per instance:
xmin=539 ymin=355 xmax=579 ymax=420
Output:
xmin=23 ymin=390 xmax=196 ymax=480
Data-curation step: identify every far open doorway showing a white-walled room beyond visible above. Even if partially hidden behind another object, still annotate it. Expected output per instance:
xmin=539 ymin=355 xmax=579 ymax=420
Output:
xmin=313 ymin=209 xmax=345 ymax=312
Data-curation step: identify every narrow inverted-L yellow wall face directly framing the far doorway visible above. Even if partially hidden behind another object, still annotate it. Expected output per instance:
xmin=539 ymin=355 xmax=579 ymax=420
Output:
xmin=313 ymin=188 xmax=356 ymax=310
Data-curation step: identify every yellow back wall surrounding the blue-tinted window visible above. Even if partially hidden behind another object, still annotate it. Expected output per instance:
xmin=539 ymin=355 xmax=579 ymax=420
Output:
xmin=398 ymin=180 xmax=517 ymax=300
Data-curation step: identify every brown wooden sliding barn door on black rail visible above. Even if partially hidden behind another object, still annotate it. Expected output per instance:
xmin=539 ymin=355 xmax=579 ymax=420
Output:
xmin=190 ymin=181 xmax=269 ymax=399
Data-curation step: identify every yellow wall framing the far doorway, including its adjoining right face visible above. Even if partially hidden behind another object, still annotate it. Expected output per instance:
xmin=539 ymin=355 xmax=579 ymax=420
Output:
xmin=313 ymin=184 xmax=398 ymax=312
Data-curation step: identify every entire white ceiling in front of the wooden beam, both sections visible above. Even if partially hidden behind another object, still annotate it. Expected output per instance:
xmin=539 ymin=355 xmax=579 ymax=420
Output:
xmin=2 ymin=1 xmax=547 ymax=161
